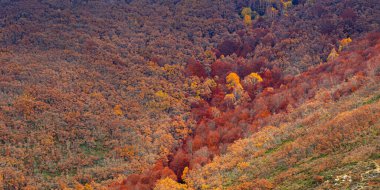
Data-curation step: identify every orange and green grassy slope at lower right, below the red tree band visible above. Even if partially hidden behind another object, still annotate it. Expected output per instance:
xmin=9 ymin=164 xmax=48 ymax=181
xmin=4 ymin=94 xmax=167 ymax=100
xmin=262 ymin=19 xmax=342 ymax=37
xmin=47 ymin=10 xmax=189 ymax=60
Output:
xmin=185 ymin=34 xmax=380 ymax=189
